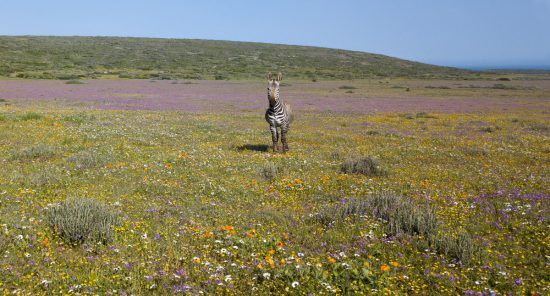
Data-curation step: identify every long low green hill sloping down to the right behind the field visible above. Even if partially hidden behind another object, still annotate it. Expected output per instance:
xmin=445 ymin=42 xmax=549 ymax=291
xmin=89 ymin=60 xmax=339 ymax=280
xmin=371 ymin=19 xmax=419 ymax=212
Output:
xmin=0 ymin=36 xmax=471 ymax=79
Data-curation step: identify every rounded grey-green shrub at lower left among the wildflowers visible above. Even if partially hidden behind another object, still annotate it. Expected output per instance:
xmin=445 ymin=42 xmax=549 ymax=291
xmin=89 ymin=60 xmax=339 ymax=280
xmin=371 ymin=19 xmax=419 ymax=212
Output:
xmin=46 ymin=198 xmax=118 ymax=244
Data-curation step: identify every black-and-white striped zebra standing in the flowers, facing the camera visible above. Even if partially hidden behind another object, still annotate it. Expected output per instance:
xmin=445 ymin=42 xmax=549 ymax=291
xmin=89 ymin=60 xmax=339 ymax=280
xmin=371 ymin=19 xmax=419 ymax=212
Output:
xmin=265 ymin=73 xmax=292 ymax=152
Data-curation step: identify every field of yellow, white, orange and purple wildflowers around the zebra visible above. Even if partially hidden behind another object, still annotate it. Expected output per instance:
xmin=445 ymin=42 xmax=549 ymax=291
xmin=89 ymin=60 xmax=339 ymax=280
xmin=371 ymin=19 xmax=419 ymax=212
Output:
xmin=0 ymin=80 xmax=550 ymax=295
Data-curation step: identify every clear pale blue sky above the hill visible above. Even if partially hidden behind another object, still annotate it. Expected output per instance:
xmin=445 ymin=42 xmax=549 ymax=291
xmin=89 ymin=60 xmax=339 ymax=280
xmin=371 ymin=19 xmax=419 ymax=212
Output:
xmin=0 ymin=0 xmax=550 ymax=69
